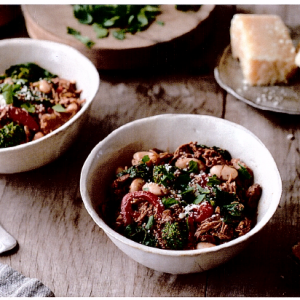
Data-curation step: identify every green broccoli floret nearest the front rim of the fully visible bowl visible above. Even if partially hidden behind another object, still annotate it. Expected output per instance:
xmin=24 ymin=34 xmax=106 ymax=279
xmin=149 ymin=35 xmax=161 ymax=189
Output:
xmin=161 ymin=222 xmax=188 ymax=250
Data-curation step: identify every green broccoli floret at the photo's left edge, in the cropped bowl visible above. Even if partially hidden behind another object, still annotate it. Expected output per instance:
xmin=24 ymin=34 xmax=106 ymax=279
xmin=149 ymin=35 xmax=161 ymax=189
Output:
xmin=0 ymin=122 xmax=26 ymax=148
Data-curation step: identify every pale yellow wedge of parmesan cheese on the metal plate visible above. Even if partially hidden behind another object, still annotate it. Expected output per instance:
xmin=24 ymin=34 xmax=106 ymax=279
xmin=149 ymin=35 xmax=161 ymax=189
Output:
xmin=230 ymin=14 xmax=297 ymax=86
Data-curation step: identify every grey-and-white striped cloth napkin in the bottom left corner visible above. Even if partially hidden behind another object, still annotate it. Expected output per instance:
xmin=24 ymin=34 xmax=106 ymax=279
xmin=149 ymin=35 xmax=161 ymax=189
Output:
xmin=0 ymin=263 xmax=55 ymax=297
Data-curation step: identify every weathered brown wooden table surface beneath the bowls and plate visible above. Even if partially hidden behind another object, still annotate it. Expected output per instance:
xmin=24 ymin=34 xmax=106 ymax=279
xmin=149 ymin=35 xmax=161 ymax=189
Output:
xmin=0 ymin=5 xmax=300 ymax=297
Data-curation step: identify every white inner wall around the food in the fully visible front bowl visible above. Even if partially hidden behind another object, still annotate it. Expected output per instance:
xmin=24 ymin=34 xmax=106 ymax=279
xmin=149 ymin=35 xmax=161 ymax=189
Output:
xmin=81 ymin=114 xmax=282 ymax=251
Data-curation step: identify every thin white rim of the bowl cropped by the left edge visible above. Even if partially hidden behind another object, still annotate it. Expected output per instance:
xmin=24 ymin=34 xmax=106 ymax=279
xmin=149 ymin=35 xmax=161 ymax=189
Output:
xmin=0 ymin=37 xmax=100 ymax=155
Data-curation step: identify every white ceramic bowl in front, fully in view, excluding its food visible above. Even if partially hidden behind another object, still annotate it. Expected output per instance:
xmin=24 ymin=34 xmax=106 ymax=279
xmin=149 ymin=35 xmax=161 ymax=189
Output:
xmin=80 ymin=114 xmax=282 ymax=274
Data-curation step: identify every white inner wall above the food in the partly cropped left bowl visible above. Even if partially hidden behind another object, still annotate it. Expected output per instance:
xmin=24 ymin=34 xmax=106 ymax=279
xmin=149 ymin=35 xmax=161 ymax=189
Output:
xmin=0 ymin=38 xmax=99 ymax=109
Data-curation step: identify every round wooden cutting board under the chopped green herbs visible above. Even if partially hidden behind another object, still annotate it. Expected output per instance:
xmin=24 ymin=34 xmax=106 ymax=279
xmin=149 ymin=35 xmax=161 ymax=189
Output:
xmin=22 ymin=5 xmax=215 ymax=69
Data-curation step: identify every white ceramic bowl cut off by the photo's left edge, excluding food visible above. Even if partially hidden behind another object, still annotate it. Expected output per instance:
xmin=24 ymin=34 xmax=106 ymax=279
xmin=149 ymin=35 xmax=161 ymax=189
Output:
xmin=0 ymin=38 xmax=100 ymax=174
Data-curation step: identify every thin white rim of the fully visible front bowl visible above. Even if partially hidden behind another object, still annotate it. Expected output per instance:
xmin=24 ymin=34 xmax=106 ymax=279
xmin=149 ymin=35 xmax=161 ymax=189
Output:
xmin=80 ymin=113 xmax=282 ymax=257
